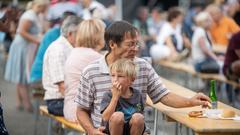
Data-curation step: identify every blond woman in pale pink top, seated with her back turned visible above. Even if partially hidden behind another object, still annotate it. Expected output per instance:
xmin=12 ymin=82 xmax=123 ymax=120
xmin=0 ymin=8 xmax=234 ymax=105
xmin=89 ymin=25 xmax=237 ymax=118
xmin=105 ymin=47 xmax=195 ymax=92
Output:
xmin=64 ymin=19 xmax=105 ymax=122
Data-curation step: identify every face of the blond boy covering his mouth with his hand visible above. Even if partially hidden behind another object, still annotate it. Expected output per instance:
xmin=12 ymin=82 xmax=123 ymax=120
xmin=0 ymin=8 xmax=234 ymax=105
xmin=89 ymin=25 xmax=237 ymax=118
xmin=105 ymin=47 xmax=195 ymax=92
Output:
xmin=111 ymin=70 xmax=134 ymax=91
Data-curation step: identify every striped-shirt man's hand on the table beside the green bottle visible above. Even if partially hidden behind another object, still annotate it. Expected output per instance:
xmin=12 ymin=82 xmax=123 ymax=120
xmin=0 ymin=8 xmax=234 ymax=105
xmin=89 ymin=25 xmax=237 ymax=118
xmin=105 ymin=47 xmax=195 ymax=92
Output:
xmin=190 ymin=93 xmax=211 ymax=107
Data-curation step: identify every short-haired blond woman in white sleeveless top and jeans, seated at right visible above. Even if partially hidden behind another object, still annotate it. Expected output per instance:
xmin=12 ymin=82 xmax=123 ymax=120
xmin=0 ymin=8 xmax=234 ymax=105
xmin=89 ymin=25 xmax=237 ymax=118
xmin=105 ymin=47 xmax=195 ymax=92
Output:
xmin=192 ymin=12 xmax=223 ymax=72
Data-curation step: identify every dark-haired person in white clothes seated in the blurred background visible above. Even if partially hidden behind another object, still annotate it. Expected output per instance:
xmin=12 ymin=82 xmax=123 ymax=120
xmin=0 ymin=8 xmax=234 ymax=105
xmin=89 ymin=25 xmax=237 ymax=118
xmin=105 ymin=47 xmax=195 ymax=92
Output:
xmin=150 ymin=7 xmax=191 ymax=61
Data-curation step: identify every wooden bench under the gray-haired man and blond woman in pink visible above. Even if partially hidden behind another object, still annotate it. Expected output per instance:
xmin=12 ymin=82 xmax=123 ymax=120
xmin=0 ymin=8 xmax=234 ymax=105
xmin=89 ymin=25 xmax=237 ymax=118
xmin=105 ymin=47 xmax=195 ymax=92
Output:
xmin=39 ymin=106 xmax=85 ymax=135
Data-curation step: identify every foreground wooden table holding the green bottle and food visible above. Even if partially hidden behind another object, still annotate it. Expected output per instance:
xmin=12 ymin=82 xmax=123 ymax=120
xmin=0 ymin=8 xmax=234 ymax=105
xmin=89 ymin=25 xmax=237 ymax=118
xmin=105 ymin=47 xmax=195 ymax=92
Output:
xmin=147 ymin=78 xmax=240 ymax=135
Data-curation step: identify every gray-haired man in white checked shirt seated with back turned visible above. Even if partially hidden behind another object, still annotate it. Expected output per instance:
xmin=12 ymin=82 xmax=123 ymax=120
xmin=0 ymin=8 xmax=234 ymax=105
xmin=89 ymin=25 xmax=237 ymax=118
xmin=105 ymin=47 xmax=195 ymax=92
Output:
xmin=42 ymin=16 xmax=81 ymax=116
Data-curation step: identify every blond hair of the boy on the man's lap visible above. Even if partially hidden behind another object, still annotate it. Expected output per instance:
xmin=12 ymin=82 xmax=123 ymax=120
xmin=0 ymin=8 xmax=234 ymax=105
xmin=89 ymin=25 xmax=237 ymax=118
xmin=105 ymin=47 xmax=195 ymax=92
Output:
xmin=110 ymin=58 xmax=137 ymax=78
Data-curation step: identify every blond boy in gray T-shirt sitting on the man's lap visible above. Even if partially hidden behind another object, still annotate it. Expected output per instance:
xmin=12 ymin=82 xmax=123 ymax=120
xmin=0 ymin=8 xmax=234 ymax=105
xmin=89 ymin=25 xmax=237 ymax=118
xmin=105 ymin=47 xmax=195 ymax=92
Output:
xmin=101 ymin=59 xmax=145 ymax=135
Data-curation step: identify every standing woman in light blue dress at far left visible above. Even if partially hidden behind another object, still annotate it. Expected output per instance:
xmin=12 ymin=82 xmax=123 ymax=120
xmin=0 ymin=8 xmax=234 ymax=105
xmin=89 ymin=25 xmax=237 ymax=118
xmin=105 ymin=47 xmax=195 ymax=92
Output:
xmin=5 ymin=0 xmax=49 ymax=112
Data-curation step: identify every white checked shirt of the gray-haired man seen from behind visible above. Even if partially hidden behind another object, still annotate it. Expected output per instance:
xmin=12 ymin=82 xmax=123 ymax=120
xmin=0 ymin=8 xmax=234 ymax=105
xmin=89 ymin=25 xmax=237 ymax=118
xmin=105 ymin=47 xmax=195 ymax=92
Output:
xmin=42 ymin=36 xmax=73 ymax=100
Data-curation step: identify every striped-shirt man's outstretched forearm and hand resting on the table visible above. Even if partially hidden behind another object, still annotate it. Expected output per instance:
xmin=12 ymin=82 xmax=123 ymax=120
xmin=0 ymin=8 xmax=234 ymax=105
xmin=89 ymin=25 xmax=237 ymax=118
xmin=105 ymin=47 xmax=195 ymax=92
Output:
xmin=160 ymin=92 xmax=211 ymax=108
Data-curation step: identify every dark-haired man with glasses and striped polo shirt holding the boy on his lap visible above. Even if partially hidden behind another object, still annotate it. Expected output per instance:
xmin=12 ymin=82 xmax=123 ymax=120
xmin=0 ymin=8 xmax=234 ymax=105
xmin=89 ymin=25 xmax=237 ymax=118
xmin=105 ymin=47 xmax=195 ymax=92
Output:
xmin=76 ymin=21 xmax=209 ymax=135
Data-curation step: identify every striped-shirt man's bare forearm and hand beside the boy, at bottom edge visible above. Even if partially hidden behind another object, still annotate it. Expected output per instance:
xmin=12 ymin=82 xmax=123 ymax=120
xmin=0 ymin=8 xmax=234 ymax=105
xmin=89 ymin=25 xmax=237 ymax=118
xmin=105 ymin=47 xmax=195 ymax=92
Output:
xmin=77 ymin=107 xmax=105 ymax=135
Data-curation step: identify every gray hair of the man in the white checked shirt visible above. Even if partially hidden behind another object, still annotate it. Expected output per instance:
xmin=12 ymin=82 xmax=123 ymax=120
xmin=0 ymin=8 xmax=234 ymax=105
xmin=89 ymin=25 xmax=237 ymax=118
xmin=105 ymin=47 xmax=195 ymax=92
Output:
xmin=61 ymin=15 xmax=82 ymax=37
